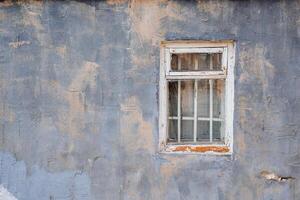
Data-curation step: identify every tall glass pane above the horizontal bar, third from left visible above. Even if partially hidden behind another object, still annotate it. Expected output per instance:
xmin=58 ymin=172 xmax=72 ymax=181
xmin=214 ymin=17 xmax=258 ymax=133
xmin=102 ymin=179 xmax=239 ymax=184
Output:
xmin=197 ymin=80 xmax=209 ymax=117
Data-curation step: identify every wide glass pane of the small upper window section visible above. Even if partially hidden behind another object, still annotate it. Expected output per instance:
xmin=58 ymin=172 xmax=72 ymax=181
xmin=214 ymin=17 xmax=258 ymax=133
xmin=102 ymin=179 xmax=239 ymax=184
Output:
xmin=171 ymin=53 xmax=222 ymax=71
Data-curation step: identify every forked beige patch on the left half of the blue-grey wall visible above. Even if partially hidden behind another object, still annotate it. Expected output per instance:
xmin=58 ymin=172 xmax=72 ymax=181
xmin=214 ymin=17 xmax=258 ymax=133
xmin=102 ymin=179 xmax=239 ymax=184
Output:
xmin=43 ymin=61 xmax=100 ymax=137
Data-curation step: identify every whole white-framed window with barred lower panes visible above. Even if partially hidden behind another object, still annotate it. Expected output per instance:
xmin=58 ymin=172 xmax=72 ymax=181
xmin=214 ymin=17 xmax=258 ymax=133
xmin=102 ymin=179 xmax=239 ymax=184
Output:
xmin=159 ymin=41 xmax=234 ymax=154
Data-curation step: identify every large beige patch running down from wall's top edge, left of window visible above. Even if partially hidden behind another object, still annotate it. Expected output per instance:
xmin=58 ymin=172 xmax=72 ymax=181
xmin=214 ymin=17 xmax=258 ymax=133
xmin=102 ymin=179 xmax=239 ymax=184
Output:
xmin=126 ymin=0 xmax=184 ymax=84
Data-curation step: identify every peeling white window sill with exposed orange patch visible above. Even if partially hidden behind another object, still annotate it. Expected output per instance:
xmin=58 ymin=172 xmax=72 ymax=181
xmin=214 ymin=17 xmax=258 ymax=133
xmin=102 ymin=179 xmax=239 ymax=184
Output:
xmin=161 ymin=144 xmax=232 ymax=155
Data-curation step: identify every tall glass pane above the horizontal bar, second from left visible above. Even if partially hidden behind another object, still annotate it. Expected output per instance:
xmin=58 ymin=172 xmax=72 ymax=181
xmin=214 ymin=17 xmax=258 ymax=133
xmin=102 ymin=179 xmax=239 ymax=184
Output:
xmin=181 ymin=81 xmax=194 ymax=117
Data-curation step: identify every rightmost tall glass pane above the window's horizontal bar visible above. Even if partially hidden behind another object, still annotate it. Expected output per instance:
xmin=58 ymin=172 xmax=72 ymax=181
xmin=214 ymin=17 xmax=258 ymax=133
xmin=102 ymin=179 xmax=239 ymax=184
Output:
xmin=213 ymin=80 xmax=224 ymax=118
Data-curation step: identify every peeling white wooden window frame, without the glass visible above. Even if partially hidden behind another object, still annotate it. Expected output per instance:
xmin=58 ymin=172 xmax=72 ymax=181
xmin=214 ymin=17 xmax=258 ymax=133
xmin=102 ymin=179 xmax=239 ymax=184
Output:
xmin=159 ymin=40 xmax=235 ymax=155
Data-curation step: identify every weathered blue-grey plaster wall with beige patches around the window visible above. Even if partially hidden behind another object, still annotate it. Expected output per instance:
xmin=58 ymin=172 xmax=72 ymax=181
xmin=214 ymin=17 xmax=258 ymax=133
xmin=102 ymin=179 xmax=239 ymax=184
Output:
xmin=0 ymin=0 xmax=300 ymax=200
